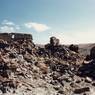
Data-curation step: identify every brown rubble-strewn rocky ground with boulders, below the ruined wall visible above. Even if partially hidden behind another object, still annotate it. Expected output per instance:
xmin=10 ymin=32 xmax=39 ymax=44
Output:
xmin=0 ymin=33 xmax=95 ymax=95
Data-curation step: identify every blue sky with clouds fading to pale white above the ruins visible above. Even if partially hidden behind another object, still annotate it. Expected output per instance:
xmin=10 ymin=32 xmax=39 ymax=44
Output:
xmin=0 ymin=0 xmax=95 ymax=44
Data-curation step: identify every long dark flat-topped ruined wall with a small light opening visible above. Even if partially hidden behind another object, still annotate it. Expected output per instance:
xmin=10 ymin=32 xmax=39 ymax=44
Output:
xmin=0 ymin=33 xmax=33 ymax=41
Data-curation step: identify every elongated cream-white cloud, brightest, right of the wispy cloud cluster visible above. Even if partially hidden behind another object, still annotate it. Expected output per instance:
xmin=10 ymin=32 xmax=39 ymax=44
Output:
xmin=25 ymin=22 xmax=50 ymax=32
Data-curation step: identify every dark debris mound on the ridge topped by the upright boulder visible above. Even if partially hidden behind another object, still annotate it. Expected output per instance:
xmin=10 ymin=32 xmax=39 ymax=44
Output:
xmin=37 ymin=37 xmax=81 ymax=63
